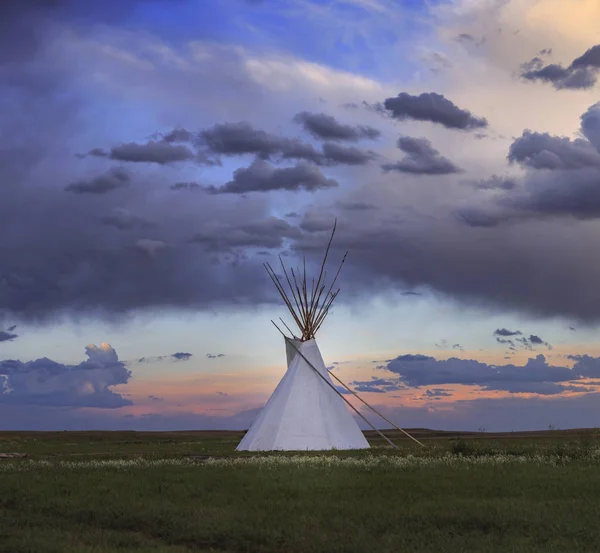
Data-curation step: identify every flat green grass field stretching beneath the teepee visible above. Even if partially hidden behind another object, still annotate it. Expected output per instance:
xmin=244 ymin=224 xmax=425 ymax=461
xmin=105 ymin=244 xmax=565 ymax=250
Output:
xmin=0 ymin=430 xmax=600 ymax=553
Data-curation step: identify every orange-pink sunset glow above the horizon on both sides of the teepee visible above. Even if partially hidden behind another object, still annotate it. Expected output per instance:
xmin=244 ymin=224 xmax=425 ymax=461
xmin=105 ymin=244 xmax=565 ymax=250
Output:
xmin=108 ymin=345 xmax=600 ymax=416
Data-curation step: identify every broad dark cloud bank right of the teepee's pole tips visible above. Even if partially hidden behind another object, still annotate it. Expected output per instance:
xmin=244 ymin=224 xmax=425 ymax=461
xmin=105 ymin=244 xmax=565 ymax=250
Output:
xmin=293 ymin=198 xmax=600 ymax=324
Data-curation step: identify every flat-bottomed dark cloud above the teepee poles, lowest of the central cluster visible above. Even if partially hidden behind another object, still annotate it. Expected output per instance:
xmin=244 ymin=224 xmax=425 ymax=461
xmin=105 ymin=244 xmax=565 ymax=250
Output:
xmin=207 ymin=159 xmax=338 ymax=194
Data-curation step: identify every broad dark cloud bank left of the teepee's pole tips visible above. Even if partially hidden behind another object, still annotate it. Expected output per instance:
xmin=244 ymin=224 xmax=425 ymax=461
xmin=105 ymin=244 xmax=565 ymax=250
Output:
xmin=0 ymin=196 xmax=292 ymax=321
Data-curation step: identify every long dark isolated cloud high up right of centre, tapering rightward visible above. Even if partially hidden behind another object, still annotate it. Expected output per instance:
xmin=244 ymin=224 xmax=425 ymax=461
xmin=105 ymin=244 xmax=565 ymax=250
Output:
xmin=383 ymin=92 xmax=488 ymax=130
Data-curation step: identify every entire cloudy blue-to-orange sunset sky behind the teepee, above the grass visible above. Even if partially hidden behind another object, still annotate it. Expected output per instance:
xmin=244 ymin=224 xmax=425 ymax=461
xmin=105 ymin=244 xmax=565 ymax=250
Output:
xmin=0 ymin=0 xmax=600 ymax=431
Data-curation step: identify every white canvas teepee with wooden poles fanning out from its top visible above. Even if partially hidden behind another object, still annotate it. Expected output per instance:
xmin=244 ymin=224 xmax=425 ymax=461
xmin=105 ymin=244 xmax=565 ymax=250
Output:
xmin=237 ymin=225 xmax=369 ymax=451
